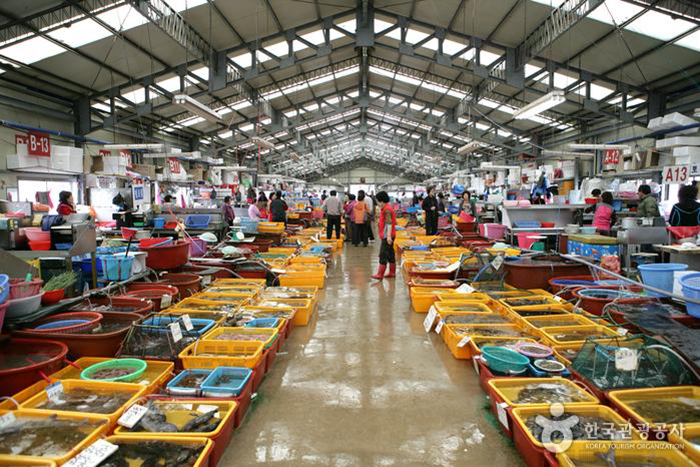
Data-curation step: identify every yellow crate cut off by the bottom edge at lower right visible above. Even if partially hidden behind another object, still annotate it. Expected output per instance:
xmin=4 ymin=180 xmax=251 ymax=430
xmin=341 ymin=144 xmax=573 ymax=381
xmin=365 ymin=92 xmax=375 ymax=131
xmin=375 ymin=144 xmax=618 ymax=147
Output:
xmin=556 ymin=441 xmax=697 ymax=467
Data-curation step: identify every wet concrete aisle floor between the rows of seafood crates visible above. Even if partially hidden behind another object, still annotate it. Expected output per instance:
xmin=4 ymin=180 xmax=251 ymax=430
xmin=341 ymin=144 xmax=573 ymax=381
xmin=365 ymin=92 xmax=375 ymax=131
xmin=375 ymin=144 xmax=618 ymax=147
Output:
xmin=219 ymin=241 xmax=521 ymax=466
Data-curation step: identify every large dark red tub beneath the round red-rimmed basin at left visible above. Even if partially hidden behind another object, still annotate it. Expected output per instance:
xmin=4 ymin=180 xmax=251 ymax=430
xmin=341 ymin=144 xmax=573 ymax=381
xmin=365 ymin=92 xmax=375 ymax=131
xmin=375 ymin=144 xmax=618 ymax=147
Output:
xmin=15 ymin=311 xmax=143 ymax=360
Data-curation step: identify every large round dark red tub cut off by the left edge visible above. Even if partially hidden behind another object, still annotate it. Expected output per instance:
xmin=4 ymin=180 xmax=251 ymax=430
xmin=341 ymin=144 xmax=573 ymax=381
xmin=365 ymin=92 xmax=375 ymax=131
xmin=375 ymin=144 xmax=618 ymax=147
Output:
xmin=0 ymin=337 xmax=68 ymax=396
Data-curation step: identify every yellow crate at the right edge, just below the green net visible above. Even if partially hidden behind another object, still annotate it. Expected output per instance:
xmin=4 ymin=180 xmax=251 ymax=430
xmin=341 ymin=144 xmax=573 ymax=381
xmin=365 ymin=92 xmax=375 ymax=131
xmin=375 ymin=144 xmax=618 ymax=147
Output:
xmin=608 ymin=386 xmax=700 ymax=430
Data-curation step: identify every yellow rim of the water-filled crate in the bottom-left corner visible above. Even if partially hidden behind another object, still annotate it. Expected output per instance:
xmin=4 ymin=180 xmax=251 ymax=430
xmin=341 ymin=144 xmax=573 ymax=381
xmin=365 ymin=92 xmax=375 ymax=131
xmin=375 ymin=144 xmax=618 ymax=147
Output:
xmin=0 ymin=409 xmax=109 ymax=465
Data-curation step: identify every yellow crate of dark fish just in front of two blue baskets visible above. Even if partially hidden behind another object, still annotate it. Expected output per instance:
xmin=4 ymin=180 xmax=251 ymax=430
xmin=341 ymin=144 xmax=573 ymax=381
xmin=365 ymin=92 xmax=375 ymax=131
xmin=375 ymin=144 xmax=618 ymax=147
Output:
xmin=114 ymin=398 xmax=238 ymax=439
